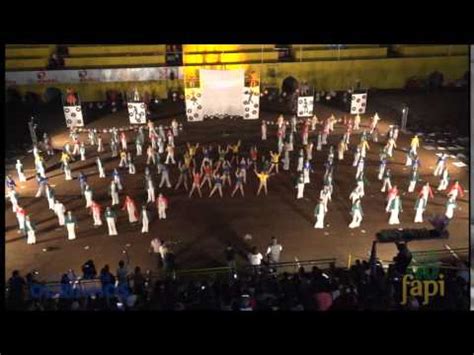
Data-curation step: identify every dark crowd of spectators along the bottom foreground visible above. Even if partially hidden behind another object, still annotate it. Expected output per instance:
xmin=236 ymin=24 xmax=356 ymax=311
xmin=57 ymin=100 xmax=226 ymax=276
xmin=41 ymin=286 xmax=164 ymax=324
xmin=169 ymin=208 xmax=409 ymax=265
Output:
xmin=7 ymin=246 xmax=470 ymax=311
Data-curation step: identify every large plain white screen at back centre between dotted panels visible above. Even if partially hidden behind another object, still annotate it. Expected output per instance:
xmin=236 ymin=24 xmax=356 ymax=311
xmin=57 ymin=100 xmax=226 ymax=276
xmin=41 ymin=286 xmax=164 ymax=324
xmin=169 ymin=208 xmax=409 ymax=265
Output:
xmin=199 ymin=69 xmax=245 ymax=116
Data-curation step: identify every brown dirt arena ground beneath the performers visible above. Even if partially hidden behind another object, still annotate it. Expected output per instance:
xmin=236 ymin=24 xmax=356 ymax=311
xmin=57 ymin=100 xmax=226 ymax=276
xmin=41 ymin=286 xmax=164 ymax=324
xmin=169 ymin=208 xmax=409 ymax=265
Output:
xmin=5 ymin=90 xmax=469 ymax=280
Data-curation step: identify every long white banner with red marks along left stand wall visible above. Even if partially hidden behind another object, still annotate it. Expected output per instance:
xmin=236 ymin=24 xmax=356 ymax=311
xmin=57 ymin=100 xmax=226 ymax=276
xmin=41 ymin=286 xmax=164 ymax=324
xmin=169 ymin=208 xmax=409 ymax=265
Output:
xmin=5 ymin=67 xmax=183 ymax=86
